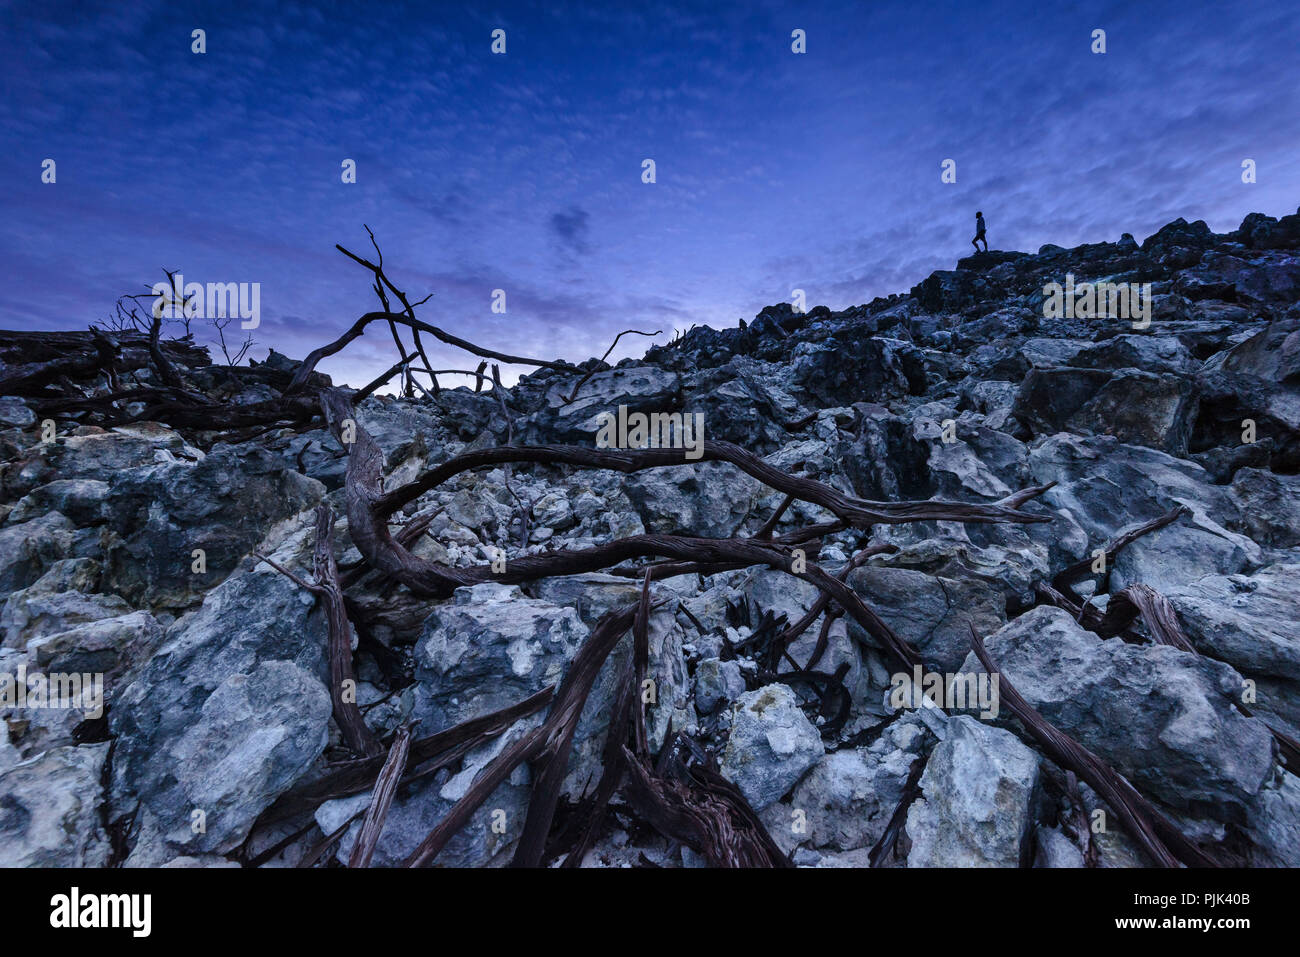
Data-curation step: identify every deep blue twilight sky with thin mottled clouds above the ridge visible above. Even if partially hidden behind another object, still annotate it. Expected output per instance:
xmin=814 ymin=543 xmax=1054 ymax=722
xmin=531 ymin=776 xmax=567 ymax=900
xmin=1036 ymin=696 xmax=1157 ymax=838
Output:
xmin=0 ymin=0 xmax=1300 ymax=386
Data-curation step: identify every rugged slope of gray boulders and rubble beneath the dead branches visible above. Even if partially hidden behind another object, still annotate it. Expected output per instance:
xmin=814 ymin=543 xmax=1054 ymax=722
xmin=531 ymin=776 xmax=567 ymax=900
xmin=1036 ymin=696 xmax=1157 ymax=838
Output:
xmin=0 ymin=213 xmax=1300 ymax=867
